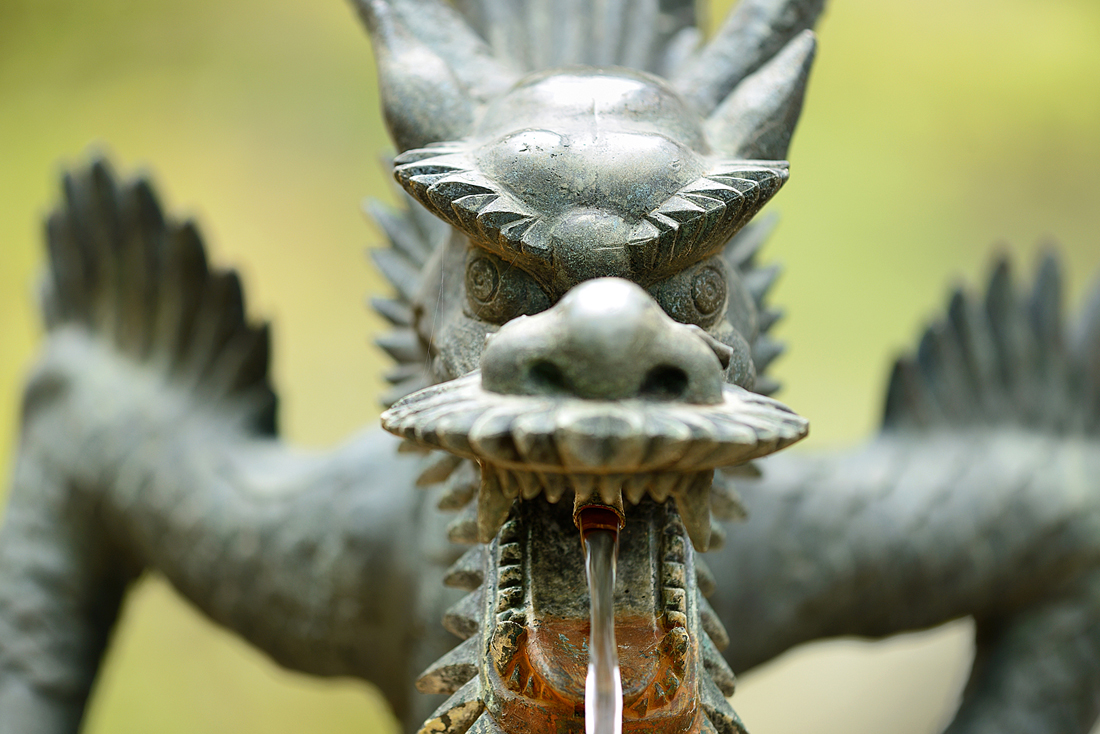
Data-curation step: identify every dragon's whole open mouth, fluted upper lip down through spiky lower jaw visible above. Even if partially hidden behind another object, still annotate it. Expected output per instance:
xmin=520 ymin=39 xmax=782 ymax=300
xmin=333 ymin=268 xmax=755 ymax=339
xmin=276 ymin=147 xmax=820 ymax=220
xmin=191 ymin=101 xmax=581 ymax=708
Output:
xmin=382 ymin=354 xmax=807 ymax=734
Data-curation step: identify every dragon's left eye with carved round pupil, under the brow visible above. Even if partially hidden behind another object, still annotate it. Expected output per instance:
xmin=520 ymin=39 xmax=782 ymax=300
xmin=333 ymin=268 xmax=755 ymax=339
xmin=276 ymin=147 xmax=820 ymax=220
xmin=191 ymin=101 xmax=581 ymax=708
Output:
xmin=466 ymin=248 xmax=550 ymax=324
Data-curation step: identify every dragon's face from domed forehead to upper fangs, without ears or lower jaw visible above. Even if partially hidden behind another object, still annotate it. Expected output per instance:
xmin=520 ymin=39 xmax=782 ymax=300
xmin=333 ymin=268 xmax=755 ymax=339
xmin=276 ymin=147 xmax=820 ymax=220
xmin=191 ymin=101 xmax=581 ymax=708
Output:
xmin=384 ymin=69 xmax=805 ymax=550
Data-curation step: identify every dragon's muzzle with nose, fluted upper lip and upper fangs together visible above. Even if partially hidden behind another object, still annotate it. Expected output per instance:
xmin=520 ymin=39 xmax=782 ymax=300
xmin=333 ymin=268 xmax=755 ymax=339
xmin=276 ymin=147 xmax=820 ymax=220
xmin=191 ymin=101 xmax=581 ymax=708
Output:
xmin=382 ymin=277 xmax=807 ymax=550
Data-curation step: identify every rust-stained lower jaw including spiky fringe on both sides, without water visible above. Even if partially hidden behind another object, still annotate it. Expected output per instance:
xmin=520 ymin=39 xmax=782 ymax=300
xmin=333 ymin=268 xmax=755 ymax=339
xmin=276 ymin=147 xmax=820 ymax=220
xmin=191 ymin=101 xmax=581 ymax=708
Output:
xmin=418 ymin=497 xmax=744 ymax=734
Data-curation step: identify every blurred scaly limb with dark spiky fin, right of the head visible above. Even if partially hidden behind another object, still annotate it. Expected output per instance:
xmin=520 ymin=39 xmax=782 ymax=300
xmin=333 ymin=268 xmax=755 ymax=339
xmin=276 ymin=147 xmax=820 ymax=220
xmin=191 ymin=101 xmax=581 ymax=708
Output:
xmin=707 ymin=258 xmax=1100 ymax=734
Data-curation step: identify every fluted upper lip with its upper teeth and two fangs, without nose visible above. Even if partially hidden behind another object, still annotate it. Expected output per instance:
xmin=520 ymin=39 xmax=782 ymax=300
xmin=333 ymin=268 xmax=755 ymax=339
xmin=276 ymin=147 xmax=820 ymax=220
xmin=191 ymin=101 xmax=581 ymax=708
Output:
xmin=382 ymin=372 xmax=807 ymax=550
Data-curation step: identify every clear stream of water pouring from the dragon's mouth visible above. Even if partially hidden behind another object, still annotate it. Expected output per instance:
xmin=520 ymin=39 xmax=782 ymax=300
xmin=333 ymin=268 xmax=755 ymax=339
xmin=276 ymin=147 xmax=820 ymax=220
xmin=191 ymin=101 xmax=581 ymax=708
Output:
xmin=583 ymin=529 xmax=623 ymax=734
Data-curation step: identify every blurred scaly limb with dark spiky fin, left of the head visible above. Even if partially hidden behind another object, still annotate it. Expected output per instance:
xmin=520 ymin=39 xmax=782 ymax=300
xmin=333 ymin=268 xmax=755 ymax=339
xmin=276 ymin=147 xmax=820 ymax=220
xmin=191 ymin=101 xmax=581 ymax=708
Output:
xmin=0 ymin=163 xmax=437 ymax=734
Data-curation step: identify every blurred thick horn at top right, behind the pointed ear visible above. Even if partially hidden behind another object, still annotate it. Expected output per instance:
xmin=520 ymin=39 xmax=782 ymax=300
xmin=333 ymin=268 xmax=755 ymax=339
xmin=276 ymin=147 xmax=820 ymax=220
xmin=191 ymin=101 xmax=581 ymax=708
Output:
xmin=672 ymin=0 xmax=825 ymax=114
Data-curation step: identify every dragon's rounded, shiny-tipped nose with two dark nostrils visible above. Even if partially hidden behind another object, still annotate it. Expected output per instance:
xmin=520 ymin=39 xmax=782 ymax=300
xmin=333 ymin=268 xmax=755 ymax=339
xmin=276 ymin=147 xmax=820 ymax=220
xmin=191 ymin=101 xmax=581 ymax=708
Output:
xmin=481 ymin=277 xmax=732 ymax=405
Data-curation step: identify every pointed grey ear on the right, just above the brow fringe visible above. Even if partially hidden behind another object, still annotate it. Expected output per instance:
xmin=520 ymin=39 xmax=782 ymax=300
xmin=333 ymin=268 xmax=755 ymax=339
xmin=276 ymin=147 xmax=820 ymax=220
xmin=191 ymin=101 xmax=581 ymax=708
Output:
xmin=705 ymin=31 xmax=817 ymax=161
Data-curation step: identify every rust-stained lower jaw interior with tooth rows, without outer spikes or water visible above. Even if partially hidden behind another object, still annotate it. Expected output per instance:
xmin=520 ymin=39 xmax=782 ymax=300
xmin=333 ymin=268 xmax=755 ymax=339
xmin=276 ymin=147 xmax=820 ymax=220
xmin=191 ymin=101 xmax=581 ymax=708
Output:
xmin=483 ymin=500 xmax=706 ymax=734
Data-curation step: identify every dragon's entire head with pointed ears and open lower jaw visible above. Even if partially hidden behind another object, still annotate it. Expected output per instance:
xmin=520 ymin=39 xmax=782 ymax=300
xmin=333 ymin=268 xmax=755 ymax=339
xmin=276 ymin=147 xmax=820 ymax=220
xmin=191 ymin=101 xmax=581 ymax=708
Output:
xmin=363 ymin=0 xmax=814 ymax=734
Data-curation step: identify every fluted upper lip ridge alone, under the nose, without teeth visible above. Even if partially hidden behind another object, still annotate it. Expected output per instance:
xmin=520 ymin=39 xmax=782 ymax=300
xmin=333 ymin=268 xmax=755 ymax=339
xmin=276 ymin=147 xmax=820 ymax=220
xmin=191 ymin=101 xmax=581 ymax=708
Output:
xmin=382 ymin=371 xmax=809 ymax=474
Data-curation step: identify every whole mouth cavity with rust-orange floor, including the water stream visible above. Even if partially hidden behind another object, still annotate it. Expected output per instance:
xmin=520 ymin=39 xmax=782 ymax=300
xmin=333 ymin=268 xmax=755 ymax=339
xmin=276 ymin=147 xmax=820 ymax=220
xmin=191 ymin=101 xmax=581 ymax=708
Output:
xmin=464 ymin=499 xmax=712 ymax=734
